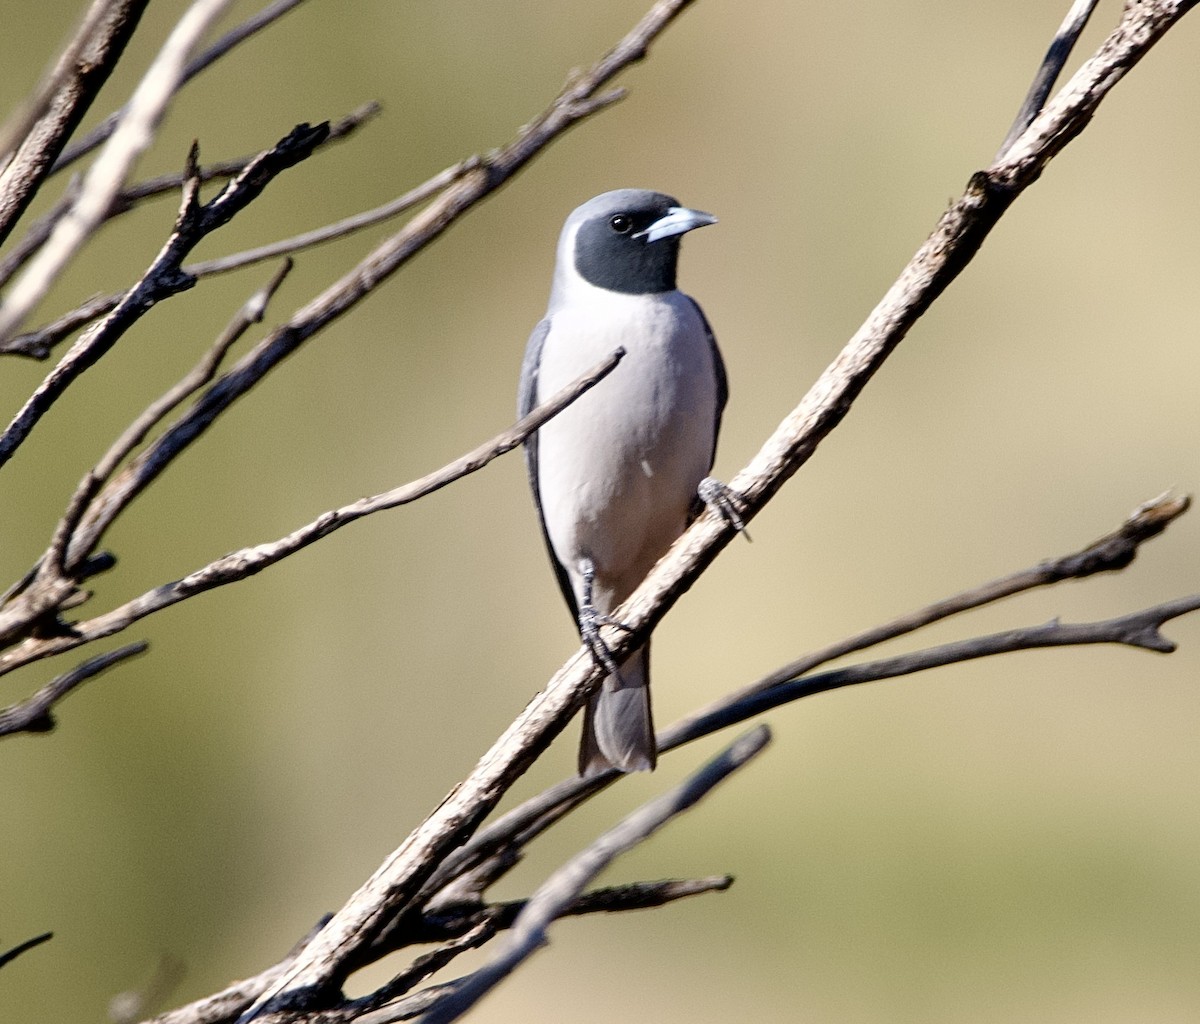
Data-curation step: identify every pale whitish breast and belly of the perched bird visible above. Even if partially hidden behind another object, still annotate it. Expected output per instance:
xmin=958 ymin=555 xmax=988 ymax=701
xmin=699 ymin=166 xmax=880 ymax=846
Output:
xmin=538 ymin=283 xmax=716 ymax=611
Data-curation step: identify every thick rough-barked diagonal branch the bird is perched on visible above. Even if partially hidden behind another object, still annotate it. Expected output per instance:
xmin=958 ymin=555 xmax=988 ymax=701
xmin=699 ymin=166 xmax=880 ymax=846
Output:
xmin=223 ymin=7 xmax=1192 ymax=1019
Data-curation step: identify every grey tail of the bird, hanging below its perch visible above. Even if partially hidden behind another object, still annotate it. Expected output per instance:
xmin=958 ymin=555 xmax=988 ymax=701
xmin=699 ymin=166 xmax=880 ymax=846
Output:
xmin=580 ymin=643 xmax=658 ymax=776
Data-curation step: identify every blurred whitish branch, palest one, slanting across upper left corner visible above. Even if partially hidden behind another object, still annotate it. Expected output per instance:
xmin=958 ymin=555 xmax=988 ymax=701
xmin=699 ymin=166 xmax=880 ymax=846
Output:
xmin=0 ymin=0 xmax=232 ymax=342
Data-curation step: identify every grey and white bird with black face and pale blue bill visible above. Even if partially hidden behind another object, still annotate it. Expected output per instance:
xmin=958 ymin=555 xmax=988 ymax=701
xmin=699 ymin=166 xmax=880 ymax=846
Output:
xmin=517 ymin=188 xmax=742 ymax=777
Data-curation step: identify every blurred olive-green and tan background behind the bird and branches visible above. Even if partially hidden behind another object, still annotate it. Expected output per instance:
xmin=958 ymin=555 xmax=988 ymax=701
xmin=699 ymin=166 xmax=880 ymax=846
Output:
xmin=0 ymin=0 xmax=1200 ymax=1024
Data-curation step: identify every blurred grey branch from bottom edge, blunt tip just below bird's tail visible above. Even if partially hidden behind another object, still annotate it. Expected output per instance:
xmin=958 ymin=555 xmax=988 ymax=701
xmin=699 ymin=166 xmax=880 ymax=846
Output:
xmin=422 ymin=725 xmax=770 ymax=1024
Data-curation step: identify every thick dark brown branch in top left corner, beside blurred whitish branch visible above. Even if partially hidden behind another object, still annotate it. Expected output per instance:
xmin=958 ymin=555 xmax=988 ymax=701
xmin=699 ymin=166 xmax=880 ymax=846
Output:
xmin=0 ymin=0 xmax=148 ymax=244
